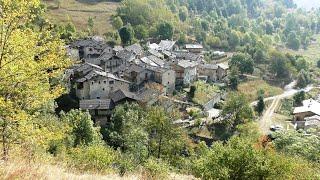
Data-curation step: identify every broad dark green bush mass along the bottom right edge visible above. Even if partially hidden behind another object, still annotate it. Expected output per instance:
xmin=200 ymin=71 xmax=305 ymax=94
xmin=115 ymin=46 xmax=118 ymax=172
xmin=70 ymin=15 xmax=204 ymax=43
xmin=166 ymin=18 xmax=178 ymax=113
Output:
xmin=193 ymin=137 xmax=319 ymax=179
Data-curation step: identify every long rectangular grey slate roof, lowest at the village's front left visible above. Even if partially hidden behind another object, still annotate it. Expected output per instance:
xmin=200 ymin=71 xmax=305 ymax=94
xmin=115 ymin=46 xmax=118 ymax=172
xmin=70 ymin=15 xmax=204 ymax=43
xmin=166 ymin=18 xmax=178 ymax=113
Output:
xmin=80 ymin=99 xmax=114 ymax=110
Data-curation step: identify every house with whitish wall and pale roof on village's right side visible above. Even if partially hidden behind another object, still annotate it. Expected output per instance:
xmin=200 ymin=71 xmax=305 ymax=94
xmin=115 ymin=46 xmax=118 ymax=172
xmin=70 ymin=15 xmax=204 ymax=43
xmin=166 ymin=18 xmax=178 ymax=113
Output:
xmin=173 ymin=60 xmax=198 ymax=85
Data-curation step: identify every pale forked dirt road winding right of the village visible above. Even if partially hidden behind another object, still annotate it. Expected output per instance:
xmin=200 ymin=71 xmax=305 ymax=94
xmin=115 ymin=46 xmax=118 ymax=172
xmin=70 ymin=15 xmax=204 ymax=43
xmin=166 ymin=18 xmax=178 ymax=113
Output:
xmin=251 ymin=81 xmax=320 ymax=134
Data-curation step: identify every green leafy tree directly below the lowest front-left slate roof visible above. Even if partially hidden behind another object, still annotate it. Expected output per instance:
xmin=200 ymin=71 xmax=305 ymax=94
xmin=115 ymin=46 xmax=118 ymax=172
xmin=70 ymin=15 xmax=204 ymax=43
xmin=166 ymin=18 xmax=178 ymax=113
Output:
xmin=61 ymin=110 xmax=102 ymax=147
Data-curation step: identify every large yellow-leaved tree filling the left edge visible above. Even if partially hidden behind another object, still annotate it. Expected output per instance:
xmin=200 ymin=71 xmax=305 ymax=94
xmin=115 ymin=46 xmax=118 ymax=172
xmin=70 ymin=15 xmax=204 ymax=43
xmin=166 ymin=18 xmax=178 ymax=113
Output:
xmin=0 ymin=0 xmax=70 ymax=159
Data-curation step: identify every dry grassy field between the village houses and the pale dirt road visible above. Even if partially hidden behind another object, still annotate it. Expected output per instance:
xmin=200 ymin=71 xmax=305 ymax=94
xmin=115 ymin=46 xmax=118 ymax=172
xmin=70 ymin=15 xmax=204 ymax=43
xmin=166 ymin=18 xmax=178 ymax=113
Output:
xmin=238 ymin=80 xmax=283 ymax=102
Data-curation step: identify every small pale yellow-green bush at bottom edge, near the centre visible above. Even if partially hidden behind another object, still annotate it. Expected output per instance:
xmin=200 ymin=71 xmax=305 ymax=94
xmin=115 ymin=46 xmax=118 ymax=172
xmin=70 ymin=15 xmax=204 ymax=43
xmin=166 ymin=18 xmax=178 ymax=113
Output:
xmin=143 ymin=158 xmax=169 ymax=179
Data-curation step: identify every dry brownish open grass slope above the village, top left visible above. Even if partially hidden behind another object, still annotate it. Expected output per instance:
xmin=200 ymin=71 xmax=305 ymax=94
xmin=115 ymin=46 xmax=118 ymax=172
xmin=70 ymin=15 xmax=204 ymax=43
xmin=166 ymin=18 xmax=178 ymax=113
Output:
xmin=44 ymin=0 xmax=119 ymax=35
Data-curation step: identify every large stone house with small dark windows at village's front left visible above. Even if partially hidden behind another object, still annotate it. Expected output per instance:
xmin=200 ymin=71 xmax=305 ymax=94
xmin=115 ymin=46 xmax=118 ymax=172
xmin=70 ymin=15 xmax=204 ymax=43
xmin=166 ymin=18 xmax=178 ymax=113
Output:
xmin=76 ymin=70 xmax=130 ymax=100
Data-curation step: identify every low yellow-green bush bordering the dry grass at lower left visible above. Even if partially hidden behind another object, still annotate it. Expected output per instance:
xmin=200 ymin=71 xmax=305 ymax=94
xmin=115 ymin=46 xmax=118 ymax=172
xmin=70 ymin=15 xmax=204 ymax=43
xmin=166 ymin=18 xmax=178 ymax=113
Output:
xmin=68 ymin=145 xmax=117 ymax=173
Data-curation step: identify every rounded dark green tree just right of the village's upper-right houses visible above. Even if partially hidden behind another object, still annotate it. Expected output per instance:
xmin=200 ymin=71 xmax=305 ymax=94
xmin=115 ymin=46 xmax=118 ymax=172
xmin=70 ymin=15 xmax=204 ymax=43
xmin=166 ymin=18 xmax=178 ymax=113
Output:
xmin=229 ymin=53 xmax=254 ymax=74
